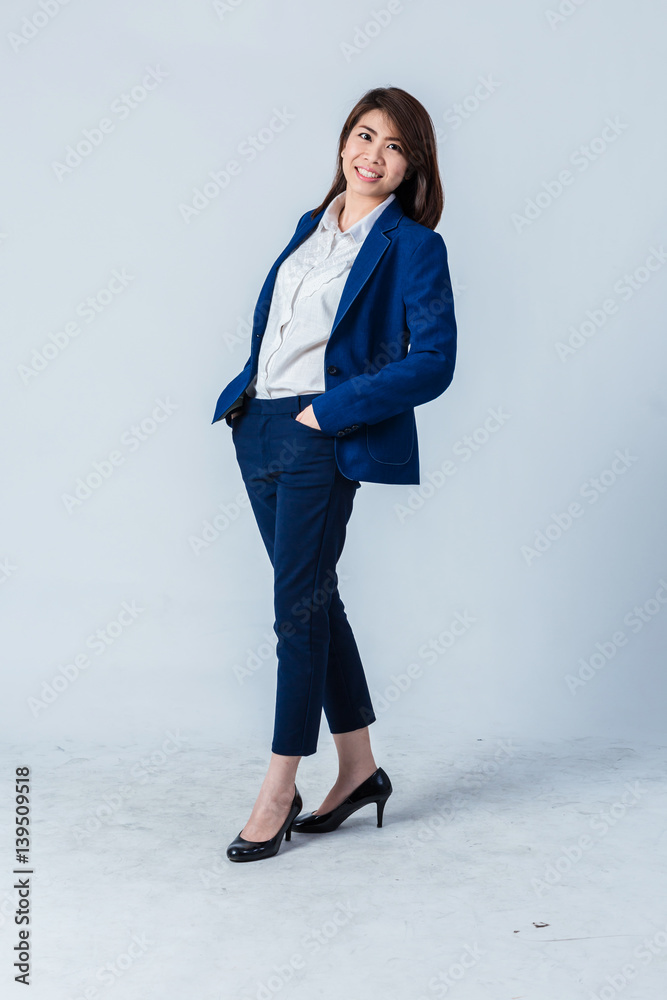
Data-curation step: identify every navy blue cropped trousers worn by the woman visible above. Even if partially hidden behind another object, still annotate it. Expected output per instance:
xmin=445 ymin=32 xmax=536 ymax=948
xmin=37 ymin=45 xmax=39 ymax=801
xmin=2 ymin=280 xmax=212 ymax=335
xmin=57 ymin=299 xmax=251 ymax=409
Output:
xmin=231 ymin=393 xmax=375 ymax=757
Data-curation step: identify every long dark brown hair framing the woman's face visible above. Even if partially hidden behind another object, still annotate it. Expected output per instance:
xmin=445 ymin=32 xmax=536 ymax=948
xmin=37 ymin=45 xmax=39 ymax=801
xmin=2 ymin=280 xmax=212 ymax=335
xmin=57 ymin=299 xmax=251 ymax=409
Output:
xmin=311 ymin=87 xmax=445 ymax=229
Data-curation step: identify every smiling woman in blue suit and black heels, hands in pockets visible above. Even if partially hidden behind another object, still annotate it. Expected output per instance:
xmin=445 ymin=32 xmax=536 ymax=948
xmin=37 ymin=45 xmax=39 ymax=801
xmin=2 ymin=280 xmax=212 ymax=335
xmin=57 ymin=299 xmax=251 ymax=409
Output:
xmin=213 ymin=87 xmax=456 ymax=861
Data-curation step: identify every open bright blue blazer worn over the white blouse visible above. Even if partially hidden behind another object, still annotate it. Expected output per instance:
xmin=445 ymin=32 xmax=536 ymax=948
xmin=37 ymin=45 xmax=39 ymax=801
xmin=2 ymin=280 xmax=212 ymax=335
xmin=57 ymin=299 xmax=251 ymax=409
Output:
xmin=213 ymin=198 xmax=456 ymax=484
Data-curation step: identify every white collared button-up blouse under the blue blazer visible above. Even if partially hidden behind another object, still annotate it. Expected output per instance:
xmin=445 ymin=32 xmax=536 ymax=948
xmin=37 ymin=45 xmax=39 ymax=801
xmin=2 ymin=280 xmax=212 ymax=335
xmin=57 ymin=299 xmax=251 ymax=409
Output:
xmin=246 ymin=191 xmax=396 ymax=399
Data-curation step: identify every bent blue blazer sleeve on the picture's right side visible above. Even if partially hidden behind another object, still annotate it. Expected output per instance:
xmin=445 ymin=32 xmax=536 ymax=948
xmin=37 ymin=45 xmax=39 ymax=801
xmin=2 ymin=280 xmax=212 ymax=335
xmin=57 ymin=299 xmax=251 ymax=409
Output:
xmin=312 ymin=230 xmax=457 ymax=434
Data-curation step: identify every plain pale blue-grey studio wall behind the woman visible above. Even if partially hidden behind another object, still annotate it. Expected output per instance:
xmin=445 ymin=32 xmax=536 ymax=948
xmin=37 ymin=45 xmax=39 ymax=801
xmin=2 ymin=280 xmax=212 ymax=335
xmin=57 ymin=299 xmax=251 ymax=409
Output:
xmin=0 ymin=0 xmax=667 ymax=750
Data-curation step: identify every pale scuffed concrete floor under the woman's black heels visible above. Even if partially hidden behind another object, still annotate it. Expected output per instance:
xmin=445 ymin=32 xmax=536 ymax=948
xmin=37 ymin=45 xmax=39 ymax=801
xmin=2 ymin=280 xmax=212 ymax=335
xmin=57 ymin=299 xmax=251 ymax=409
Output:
xmin=0 ymin=732 xmax=667 ymax=1000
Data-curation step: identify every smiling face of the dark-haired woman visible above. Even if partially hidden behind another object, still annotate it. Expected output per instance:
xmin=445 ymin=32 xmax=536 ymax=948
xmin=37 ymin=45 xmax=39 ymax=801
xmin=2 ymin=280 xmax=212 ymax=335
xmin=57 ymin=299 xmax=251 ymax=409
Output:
xmin=341 ymin=109 xmax=408 ymax=201
